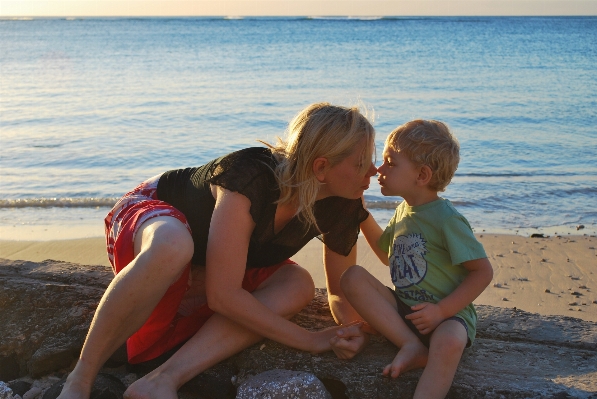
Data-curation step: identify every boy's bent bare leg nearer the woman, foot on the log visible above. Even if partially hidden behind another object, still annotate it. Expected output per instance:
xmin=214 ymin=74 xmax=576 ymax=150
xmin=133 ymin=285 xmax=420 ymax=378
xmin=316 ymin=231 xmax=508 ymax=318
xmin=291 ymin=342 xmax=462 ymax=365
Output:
xmin=340 ymin=265 xmax=428 ymax=378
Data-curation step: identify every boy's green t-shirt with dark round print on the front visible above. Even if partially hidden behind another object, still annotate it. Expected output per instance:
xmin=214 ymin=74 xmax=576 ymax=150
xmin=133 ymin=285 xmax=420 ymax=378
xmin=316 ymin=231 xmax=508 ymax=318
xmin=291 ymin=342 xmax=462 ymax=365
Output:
xmin=378 ymin=198 xmax=487 ymax=343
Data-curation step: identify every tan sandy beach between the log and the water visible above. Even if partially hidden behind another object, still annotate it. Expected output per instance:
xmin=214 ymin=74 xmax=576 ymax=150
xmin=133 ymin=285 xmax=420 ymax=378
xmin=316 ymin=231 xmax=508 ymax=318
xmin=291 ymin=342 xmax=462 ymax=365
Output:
xmin=0 ymin=233 xmax=597 ymax=322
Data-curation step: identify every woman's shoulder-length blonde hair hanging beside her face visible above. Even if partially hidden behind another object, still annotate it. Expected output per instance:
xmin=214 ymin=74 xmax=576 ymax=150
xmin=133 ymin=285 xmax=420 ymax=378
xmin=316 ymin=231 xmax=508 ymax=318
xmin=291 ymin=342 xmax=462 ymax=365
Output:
xmin=264 ymin=103 xmax=375 ymax=230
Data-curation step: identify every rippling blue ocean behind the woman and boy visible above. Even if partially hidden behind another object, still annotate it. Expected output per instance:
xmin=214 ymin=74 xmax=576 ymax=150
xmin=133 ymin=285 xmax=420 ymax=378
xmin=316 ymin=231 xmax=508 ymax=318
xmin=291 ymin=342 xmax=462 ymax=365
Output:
xmin=0 ymin=17 xmax=597 ymax=239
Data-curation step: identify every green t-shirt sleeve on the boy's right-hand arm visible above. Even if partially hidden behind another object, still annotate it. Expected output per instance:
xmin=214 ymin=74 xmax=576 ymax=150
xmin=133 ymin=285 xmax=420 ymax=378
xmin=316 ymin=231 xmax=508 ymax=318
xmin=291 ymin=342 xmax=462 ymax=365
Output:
xmin=442 ymin=215 xmax=487 ymax=265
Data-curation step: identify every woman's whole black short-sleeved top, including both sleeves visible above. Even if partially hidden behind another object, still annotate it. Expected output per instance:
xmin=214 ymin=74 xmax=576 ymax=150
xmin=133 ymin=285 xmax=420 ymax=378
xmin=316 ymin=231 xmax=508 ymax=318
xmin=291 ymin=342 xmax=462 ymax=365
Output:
xmin=157 ymin=147 xmax=368 ymax=268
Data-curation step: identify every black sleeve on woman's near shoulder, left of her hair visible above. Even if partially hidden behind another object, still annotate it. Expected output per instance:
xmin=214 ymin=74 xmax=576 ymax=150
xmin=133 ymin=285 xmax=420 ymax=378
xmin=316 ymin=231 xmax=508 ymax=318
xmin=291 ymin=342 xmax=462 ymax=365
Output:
xmin=209 ymin=151 xmax=276 ymax=223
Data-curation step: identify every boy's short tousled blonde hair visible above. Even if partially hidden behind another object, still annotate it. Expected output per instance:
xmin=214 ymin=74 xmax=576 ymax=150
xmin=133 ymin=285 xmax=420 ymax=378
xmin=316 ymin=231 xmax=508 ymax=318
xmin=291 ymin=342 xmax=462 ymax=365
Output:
xmin=386 ymin=119 xmax=460 ymax=192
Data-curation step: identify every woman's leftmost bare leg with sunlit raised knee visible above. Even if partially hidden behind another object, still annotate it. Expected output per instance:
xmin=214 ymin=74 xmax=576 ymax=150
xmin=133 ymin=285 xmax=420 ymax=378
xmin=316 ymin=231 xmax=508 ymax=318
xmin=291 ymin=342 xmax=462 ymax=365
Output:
xmin=59 ymin=216 xmax=194 ymax=399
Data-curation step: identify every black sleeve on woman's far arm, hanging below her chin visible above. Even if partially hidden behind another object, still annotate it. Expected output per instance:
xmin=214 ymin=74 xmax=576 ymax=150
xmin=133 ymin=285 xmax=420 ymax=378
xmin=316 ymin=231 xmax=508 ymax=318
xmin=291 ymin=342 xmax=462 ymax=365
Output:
xmin=317 ymin=197 xmax=369 ymax=256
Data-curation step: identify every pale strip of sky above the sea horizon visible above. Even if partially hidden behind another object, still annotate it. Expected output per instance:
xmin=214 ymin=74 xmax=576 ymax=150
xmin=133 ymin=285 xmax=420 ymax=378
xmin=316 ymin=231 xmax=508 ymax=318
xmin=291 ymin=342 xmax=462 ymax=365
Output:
xmin=0 ymin=0 xmax=597 ymax=17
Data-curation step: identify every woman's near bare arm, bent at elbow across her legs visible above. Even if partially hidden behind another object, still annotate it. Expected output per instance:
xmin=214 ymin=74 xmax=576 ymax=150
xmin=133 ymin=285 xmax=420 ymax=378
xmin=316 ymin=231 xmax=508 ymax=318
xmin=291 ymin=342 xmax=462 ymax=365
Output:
xmin=206 ymin=186 xmax=335 ymax=352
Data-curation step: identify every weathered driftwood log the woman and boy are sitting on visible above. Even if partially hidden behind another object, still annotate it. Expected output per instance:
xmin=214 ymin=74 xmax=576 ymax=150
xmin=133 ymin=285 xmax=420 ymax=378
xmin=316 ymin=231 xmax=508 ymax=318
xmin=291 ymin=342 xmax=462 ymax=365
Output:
xmin=0 ymin=259 xmax=597 ymax=398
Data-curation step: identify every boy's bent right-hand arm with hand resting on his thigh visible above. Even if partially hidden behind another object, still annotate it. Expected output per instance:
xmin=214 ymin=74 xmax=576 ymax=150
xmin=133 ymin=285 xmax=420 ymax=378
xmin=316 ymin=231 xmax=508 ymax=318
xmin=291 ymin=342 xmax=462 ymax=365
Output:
xmin=406 ymin=258 xmax=493 ymax=334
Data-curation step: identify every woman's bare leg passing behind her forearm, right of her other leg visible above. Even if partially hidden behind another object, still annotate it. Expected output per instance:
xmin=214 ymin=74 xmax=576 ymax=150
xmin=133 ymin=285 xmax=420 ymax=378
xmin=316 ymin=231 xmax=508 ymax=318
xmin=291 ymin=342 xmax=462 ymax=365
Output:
xmin=124 ymin=265 xmax=314 ymax=399
